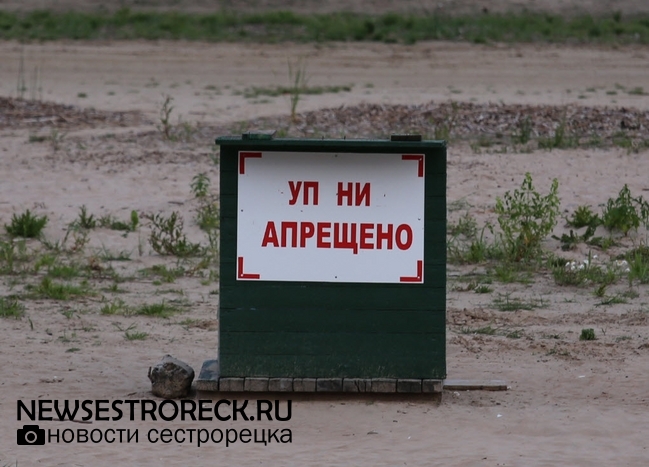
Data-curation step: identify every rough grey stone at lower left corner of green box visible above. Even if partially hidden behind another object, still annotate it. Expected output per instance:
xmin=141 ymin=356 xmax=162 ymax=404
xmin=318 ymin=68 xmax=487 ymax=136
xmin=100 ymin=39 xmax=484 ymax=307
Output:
xmin=149 ymin=355 xmax=194 ymax=399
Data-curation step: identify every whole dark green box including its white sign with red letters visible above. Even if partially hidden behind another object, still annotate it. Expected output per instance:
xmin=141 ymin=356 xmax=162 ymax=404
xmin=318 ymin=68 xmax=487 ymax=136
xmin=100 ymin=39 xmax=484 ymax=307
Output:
xmin=216 ymin=135 xmax=446 ymax=379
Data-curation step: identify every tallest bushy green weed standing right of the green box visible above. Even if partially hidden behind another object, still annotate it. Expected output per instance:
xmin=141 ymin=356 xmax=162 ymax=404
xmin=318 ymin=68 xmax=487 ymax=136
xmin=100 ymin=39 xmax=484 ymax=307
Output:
xmin=496 ymin=172 xmax=560 ymax=261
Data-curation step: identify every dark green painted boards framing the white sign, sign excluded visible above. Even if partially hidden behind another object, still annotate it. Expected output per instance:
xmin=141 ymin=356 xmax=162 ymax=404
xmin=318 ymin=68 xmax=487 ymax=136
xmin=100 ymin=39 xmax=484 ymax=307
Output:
xmin=217 ymin=138 xmax=446 ymax=378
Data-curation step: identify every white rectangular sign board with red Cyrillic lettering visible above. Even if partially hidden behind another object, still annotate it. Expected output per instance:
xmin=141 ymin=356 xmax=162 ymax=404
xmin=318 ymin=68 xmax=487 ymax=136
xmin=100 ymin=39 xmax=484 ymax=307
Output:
xmin=237 ymin=151 xmax=425 ymax=283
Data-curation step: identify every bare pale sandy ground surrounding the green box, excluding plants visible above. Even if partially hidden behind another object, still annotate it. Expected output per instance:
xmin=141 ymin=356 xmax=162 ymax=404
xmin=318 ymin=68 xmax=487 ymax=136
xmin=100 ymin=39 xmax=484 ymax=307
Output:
xmin=0 ymin=5 xmax=649 ymax=467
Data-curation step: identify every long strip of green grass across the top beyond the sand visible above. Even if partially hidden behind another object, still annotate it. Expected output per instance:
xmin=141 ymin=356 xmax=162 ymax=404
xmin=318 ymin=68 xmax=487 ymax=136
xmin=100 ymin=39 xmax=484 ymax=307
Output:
xmin=0 ymin=8 xmax=649 ymax=44
